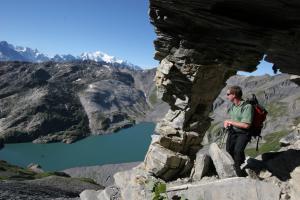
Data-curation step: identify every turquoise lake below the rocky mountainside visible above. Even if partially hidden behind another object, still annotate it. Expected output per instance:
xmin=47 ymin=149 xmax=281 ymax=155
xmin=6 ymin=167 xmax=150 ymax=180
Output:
xmin=0 ymin=123 xmax=155 ymax=171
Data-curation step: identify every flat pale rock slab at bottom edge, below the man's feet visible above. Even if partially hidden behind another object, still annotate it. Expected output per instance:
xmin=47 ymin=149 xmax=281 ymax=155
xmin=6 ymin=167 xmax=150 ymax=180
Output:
xmin=167 ymin=178 xmax=280 ymax=200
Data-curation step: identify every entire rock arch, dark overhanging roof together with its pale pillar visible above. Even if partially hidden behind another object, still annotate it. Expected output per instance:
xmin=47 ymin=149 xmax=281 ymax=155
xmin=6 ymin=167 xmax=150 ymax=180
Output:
xmin=145 ymin=0 xmax=300 ymax=180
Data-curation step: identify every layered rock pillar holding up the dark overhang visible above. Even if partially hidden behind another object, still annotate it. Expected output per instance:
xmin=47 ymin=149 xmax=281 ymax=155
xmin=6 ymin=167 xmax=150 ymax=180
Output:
xmin=145 ymin=59 xmax=231 ymax=180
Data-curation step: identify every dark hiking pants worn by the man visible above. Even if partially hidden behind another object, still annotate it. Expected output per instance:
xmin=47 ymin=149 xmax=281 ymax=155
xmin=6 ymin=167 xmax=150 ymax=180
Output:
xmin=226 ymin=131 xmax=251 ymax=176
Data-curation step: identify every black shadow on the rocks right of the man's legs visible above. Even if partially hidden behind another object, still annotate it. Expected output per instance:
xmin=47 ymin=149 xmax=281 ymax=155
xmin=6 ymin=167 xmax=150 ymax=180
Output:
xmin=246 ymin=149 xmax=300 ymax=181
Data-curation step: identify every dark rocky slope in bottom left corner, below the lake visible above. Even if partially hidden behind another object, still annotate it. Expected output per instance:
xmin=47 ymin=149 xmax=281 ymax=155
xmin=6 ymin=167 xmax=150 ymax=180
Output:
xmin=0 ymin=160 xmax=104 ymax=200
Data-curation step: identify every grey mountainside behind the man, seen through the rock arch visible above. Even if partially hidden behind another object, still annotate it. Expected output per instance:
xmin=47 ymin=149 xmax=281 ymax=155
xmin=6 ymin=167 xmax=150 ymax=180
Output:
xmin=203 ymin=74 xmax=300 ymax=150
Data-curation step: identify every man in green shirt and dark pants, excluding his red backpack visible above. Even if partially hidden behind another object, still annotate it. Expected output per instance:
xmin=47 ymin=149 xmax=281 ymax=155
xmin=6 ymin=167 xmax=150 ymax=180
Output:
xmin=224 ymin=86 xmax=254 ymax=176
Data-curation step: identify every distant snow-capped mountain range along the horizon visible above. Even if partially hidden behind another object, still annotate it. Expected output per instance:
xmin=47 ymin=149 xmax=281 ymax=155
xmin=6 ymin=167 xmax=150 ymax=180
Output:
xmin=0 ymin=41 xmax=142 ymax=70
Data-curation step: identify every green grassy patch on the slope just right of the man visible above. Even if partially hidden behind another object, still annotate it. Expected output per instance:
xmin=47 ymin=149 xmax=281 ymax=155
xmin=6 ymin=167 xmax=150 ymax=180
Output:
xmin=245 ymin=130 xmax=288 ymax=157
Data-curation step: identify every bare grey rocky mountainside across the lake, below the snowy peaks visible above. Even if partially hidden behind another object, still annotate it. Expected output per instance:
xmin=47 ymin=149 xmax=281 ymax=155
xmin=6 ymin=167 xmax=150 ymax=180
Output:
xmin=0 ymin=61 xmax=163 ymax=143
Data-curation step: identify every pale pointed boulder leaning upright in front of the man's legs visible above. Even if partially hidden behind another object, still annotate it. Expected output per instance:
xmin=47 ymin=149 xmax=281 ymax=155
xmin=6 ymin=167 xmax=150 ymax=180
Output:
xmin=209 ymin=143 xmax=236 ymax=178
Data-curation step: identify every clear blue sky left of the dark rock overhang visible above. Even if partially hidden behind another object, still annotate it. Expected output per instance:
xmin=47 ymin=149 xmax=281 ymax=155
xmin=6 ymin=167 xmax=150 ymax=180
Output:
xmin=0 ymin=0 xmax=158 ymax=67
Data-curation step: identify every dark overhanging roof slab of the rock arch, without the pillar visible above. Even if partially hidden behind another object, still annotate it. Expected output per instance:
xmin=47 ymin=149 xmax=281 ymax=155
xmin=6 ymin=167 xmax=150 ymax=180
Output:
xmin=150 ymin=0 xmax=300 ymax=74
